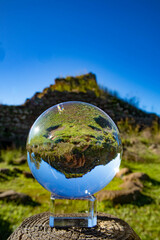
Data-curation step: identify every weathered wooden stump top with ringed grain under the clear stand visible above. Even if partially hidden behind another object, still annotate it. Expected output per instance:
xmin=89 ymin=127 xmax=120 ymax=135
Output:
xmin=8 ymin=212 xmax=140 ymax=240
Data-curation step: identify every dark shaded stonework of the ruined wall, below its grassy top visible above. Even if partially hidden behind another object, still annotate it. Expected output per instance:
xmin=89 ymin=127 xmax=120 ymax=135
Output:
xmin=0 ymin=89 xmax=159 ymax=147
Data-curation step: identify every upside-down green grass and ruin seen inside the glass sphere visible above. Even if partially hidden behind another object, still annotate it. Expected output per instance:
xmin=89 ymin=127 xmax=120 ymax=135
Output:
xmin=27 ymin=102 xmax=122 ymax=178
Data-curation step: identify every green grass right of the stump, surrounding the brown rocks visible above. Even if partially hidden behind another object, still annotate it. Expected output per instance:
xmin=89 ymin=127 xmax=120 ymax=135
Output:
xmin=99 ymin=162 xmax=160 ymax=240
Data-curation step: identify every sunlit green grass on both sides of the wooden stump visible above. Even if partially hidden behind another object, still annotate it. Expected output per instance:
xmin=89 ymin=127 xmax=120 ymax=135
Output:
xmin=0 ymin=149 xmax=160 ymax=240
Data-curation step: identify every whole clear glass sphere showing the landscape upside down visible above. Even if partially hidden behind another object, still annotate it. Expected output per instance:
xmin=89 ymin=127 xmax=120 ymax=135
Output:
xmin=27 ymin=101 xmax=122 ymax=198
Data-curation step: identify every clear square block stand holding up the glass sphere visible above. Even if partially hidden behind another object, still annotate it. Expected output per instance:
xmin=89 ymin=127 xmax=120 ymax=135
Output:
xmin=49 ymin=194 xmax=97 ymax=227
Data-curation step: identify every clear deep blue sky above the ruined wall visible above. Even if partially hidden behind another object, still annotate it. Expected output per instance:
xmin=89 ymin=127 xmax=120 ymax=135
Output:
xmin=0 ymin=0 xmax=160 ymax=114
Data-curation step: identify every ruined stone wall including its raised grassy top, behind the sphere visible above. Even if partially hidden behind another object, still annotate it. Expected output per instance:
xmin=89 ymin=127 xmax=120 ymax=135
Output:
xmin=0 ymin=73 xmax=160 ymax=147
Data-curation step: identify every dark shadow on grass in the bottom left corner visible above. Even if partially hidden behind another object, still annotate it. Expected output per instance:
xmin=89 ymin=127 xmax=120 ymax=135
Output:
xmin=0 ymin=215 xmax=12 ymax=240
